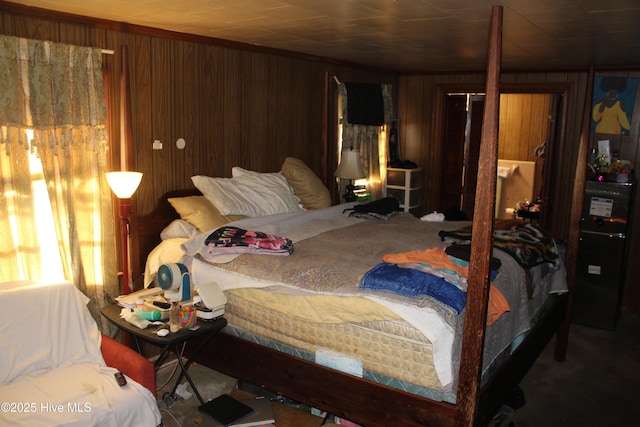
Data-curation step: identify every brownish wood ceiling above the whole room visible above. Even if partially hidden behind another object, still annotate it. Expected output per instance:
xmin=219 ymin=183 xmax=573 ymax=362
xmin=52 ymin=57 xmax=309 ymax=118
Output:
xmin=0 ymin=0 xmax=640 ymax=73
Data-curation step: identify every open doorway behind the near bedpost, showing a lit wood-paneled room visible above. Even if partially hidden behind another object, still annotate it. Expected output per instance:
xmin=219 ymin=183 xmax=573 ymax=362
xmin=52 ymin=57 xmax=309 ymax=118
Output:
xmin=440 ymin=92 xmax=563 ymax=219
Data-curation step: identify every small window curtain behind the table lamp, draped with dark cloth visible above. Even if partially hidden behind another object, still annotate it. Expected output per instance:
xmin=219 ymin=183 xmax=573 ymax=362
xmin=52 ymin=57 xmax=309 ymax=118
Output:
xmin=338 ymin=83 xmax=393 ymax=200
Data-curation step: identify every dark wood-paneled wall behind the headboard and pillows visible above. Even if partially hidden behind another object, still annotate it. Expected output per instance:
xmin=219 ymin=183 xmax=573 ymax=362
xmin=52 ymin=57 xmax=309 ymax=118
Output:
xmin=0 ymin=4 xmax=397 ymax=213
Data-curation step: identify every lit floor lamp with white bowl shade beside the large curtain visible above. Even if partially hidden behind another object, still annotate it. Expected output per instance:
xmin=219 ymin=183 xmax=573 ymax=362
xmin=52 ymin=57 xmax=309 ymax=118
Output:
xmin=106 ymin=171 xmax=142 ymax=294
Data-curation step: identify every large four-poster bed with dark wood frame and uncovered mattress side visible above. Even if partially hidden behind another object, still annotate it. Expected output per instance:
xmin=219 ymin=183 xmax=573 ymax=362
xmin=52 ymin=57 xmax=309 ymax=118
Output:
xmin=125 ymin=8 xmax=580 ymax=426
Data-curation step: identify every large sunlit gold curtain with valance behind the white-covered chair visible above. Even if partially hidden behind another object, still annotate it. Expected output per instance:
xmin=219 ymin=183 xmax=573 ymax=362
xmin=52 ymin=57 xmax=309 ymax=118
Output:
xmin=0 ymin=36 xmax=119 ymax=332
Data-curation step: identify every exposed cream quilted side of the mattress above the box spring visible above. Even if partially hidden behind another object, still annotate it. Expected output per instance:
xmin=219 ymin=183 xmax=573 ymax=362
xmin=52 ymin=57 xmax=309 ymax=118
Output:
xmin=225 ymin=289 xmax=444 ymax=390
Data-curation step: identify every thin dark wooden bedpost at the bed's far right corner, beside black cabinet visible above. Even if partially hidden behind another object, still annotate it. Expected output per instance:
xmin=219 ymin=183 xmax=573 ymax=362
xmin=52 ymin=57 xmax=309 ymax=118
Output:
xmin=553 ymin=65 xmax=595 ymax=362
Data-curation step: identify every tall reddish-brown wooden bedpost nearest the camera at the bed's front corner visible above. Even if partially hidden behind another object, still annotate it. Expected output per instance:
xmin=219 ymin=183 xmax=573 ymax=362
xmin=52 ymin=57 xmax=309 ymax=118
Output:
xmin=455 ymin=6 xmax=502 ymax=427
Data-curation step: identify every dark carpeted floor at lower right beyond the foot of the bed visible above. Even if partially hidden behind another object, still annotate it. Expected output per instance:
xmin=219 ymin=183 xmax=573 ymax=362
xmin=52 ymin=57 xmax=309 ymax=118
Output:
xmin=513 ymin=314 xmax=640 ymax=427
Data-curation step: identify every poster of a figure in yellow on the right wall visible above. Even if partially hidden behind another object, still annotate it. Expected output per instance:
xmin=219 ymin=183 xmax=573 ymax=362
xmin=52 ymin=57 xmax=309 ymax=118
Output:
xmin=591 ymin=76 xmax=638 ymax=135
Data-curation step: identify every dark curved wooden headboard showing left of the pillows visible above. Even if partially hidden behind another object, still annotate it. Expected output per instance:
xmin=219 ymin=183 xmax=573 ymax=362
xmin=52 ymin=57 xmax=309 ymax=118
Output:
xmin=129 ymin=188 xmax=202 ymax=291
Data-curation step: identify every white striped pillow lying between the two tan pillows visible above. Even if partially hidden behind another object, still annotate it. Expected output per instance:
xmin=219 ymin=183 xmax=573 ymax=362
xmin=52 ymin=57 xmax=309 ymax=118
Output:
xmin=191 ymin=168 xmax=302 ymax=217
